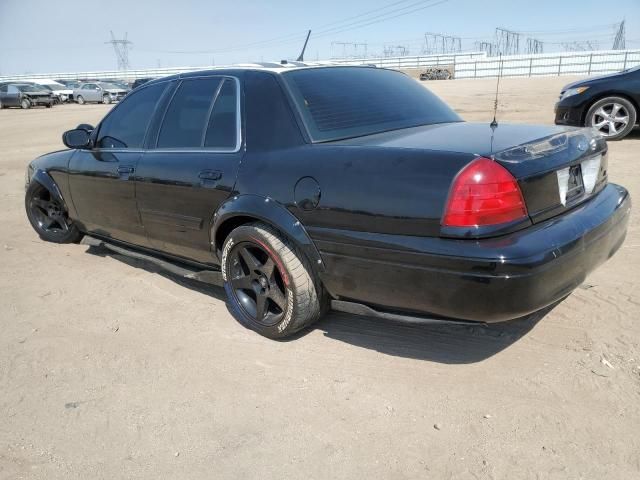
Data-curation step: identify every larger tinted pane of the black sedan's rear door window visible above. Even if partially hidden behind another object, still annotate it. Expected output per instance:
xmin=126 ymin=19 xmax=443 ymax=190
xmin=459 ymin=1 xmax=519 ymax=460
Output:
xmin=157 ymin=77 xmax=222 ymax=148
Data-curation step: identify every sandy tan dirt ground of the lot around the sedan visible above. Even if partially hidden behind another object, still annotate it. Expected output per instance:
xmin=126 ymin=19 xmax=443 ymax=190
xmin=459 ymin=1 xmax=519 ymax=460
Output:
xmin=0 ymin=77 xmax=640 ymax=480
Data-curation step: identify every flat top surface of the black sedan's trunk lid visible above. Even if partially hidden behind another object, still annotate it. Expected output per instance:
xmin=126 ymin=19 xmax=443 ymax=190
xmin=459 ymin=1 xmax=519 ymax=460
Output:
xmin=331 ymin=122 xmax=575 ymax=156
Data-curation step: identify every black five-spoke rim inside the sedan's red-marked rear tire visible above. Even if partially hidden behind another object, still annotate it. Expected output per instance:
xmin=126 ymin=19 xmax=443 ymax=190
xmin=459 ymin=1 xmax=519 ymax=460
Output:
xmin=229 ymin=242 xmax=287 ymax=327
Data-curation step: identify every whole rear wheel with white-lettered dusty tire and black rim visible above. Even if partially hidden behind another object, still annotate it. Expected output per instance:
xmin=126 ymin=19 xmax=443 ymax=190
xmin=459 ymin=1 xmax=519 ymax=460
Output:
xmin=222 ymin=223 xmax=326 ymax=339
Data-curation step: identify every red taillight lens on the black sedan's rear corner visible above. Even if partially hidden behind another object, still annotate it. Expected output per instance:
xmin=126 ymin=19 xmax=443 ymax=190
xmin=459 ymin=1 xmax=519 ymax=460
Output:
xmin=442 ymin=157 xmax=527 ymax=227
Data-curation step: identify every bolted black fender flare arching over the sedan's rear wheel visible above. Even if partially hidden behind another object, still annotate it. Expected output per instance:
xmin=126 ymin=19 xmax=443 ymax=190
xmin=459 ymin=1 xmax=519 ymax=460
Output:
xmin=210 ymin=194 xmax=324 ymax=273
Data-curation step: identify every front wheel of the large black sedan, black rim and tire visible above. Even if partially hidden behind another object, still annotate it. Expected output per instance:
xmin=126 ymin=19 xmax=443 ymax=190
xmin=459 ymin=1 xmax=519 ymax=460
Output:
xmin=24 ymin=181 xmax=84 ymax=243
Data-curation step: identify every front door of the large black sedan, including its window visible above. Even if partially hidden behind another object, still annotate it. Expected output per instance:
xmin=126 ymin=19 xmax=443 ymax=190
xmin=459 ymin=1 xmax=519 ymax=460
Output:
xmin=69 ymin=82 xmax=167 ymax=246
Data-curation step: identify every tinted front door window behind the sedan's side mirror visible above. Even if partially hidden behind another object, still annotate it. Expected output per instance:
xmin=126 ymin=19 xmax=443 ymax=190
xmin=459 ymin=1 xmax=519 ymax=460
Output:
xmin=97 ymin=83 xmax=167 ymax=148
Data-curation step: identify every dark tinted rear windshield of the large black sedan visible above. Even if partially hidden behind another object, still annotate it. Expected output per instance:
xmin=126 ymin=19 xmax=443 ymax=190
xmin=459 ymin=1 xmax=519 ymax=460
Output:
xmin=283 ymin=67 xmax=461 ymax=142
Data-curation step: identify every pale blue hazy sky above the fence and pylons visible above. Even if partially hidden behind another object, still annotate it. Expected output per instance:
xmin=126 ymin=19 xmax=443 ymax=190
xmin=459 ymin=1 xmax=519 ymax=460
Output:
xmin=0 ymin=0 xmax=640 ymax=74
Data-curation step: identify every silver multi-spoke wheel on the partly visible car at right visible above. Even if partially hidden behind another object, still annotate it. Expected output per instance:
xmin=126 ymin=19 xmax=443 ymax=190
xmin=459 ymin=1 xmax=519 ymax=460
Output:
xmin=585 ymin=97 xmax=637 ymax=140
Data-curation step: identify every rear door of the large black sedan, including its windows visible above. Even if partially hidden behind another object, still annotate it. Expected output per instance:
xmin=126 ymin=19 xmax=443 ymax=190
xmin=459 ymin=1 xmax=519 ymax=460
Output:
xmin=132 ymin=76 xmax=243 ymax=263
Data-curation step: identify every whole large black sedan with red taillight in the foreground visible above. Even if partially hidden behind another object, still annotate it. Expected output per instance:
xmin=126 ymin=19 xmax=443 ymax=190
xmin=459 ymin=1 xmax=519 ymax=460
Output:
xmin=25 ymin=67 xmax=631 ymax=338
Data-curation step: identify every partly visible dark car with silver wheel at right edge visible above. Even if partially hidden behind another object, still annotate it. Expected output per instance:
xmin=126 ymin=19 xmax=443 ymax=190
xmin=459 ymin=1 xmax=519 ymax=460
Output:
xmin=556 ymin=67 xmax=640 ymax=140
